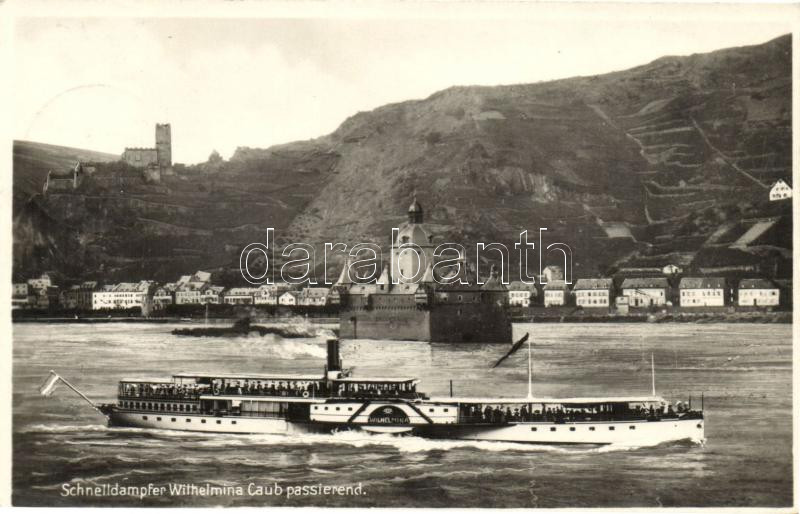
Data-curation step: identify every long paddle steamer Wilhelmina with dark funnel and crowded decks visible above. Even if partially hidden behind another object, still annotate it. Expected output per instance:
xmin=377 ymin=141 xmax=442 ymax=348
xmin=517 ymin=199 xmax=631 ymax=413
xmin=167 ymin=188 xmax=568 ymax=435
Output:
xmin=59 ymin=340 xmax=705 ymax=445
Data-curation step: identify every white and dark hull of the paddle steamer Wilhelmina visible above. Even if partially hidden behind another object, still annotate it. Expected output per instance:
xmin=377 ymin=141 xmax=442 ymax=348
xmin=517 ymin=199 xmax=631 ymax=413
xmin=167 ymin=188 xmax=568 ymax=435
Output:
xmin=103 ymin=402 xmax=705 ymax=446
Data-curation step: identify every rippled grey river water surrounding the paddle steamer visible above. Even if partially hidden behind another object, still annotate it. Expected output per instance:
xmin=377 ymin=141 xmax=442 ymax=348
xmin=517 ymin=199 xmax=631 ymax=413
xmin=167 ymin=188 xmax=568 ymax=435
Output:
xmin=12 ymin=323 xmax=792 ymax=507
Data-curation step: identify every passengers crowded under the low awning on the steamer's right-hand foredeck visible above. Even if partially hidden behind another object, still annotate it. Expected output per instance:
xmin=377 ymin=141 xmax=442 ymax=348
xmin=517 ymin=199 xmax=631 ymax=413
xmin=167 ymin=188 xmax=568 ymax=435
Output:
xmin=464 ymin=402 xmax=689 ymax=423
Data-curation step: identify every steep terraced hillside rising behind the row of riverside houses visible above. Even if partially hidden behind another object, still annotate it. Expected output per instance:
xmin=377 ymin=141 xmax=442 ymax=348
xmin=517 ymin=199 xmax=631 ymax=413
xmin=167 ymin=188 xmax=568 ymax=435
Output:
xmin=14 ymin=36 xmax=791 ymax=279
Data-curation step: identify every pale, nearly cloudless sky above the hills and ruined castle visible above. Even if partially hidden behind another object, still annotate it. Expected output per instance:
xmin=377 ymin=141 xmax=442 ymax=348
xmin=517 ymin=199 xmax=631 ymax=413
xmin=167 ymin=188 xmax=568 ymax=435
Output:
xmin=11 ymin=4 xmax=798 ymax=164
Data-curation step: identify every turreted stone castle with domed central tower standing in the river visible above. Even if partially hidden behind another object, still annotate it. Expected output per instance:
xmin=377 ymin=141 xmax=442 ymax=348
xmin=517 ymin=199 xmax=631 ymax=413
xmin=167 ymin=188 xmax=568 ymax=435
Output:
xmin=333 ymin=198 xmax=511 ymax=343
